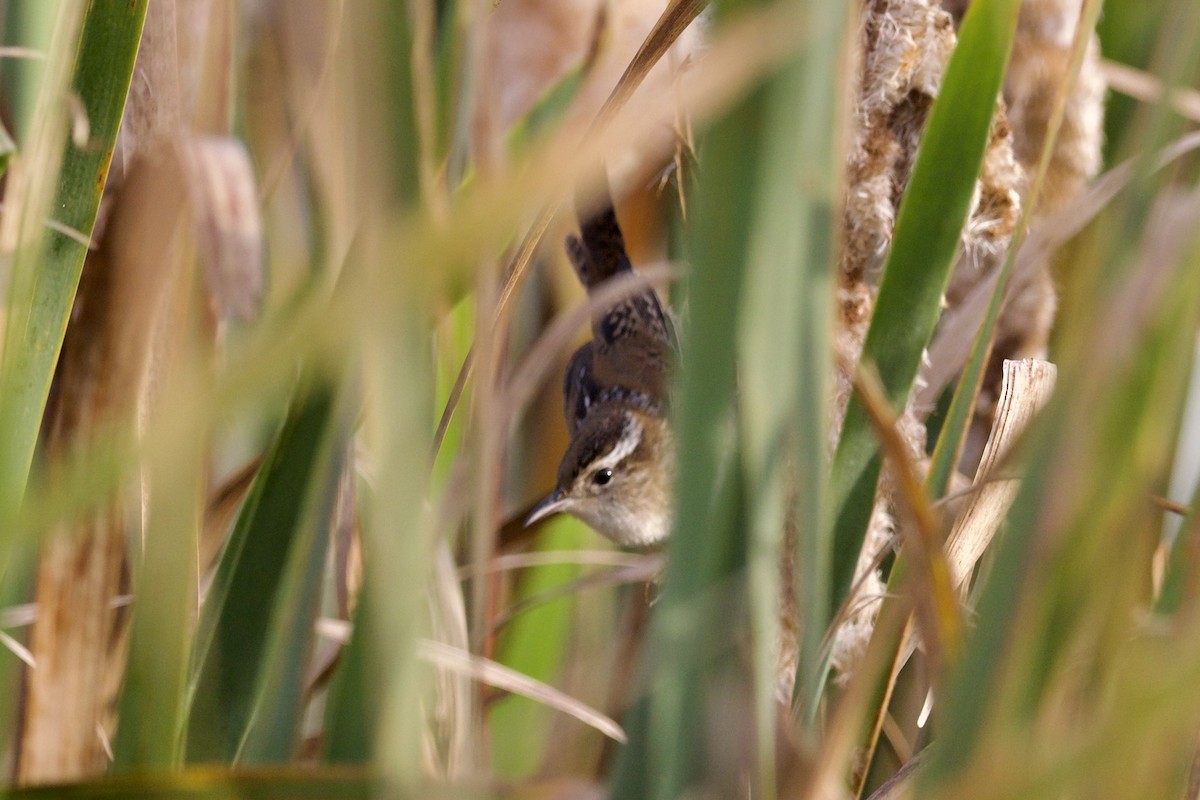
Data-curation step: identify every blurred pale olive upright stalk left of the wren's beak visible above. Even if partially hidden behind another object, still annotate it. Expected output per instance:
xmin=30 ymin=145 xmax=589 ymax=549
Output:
xmin=329 ymin=0 xmax=444 ymax=787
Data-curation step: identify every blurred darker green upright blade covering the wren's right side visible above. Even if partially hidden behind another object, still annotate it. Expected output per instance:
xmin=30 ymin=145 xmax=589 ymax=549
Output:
xmin=610 ymin=4 xmax=777 ymax=799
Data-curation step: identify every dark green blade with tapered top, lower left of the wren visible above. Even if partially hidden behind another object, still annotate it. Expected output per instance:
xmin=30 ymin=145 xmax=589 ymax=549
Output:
xmin=186 ymin=380 xmax=346 ymax=763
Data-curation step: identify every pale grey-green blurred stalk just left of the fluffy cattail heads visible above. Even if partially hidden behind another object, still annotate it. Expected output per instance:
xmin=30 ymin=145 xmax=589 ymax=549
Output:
xmin=738 ymin=2 xmax=848 ymax=783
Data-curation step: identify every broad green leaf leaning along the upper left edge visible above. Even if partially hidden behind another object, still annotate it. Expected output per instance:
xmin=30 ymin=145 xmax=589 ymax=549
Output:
xmin=0 ymin=0 xmax=146 ymax=578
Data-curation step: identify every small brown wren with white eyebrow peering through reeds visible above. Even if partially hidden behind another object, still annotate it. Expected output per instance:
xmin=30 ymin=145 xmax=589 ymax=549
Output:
xmin=526 ymin=205 xmax=679 ymax=547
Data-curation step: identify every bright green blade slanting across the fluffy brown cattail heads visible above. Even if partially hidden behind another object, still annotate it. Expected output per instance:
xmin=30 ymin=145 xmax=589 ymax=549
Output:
xmin=830 ymin=0 xmax=1020 ymax=608
